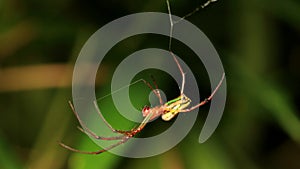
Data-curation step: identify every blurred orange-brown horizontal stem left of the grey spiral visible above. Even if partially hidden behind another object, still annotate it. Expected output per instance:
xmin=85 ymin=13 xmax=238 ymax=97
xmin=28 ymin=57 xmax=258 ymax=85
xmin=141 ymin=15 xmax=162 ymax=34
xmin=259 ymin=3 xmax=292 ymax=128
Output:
xmin=0 ymin=64 xmax=73 ymax=92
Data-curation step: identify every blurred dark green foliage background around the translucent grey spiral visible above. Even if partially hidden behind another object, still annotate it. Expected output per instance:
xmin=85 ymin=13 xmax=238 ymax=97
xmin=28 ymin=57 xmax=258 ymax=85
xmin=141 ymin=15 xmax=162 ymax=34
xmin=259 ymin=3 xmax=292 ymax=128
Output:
xmin=0 ymin=0 xmax=300 ymax=169
